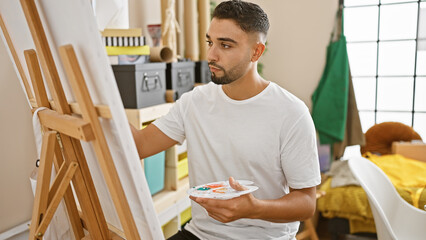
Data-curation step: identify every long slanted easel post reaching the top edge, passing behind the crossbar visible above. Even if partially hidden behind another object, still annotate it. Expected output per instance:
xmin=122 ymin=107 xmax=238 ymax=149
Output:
xmin=20 ymin=0 xmax=110 ymax=239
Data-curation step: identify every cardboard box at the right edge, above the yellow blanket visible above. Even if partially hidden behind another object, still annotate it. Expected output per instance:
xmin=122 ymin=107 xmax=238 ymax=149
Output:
xmin=392 ymin=142 xmax=426 ymax=162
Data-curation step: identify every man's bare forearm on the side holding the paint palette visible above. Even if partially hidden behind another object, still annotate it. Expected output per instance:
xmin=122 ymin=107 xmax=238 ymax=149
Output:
xmin=250 ymin=187 xmax=316 ymax=223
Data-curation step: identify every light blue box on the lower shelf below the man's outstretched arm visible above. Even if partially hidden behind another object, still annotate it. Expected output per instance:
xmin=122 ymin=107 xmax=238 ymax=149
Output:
xmin=144 ymin=151 xmax=166 ymax=195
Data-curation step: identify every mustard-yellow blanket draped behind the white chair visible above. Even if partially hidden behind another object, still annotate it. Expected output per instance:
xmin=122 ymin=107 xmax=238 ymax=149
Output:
xmin=317 ymin=153 xmax=426 ymax=233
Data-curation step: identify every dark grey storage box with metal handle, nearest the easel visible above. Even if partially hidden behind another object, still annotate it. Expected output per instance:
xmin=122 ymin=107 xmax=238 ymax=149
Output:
xmin=112 ymin=63 xmax=166 ymax=108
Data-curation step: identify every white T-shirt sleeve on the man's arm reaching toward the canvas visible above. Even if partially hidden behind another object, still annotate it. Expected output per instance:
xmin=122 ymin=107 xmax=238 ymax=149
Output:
xmin=153 ymin=92 xmax=191 ymax=144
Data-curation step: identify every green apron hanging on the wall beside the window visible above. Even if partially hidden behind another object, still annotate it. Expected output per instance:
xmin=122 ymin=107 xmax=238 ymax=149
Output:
xmin=312 ymin=8 xmax=349 ymax=144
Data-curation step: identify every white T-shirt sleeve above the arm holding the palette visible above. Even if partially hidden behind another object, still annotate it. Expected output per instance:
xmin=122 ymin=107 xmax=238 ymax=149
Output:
xmin=281 ymin=109 xmax=321 ymax=189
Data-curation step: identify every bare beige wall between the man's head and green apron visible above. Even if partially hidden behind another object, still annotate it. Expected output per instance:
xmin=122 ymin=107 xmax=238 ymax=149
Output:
xmin=251 ymin=0 xmax=338 ymax=107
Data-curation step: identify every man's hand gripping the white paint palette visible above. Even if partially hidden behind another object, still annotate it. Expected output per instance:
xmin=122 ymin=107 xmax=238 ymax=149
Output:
xmin=190 ymin=177 xmax=257 ymax=223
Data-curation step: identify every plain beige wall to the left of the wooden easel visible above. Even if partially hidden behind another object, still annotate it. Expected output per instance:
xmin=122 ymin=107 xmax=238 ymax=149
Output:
xmin=0 ymin=40 xmax=37 ymax=233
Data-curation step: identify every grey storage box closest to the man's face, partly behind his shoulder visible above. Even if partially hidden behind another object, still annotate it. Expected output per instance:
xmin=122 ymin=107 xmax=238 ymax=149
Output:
xmin=166 ymin=62 xmax=195 ymax=100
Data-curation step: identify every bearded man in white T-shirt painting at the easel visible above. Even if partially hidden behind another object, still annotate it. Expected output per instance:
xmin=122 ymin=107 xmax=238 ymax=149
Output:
xmin=133 ymin=0 xmax=320 ymax=239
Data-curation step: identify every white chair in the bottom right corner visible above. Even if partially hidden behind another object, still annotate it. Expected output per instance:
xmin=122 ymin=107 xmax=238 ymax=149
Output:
xmin=349 ymin=157 xmax=426 ymax=240
